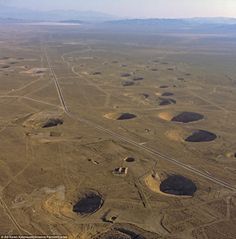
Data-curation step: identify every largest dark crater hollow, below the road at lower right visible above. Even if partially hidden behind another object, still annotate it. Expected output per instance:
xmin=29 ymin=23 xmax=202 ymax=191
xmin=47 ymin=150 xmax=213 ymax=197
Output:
xmin=160 ymin=175 xmax=197 ymax=196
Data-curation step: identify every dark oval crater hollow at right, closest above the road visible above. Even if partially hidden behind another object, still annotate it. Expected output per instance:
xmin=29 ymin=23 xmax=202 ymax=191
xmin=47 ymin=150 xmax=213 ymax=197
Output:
xmin=185 ymin=130 xmax=217 ymax=143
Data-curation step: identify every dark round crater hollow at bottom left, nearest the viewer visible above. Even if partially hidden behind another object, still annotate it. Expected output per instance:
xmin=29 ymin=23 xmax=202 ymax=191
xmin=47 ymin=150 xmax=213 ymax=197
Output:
xmin=73 ymin=191 xmax=104 ymax=216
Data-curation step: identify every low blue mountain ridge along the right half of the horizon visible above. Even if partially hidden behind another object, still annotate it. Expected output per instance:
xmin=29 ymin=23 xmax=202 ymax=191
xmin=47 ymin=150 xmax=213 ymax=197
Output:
xmin=104 ymin=18 xmax=236 ymax=33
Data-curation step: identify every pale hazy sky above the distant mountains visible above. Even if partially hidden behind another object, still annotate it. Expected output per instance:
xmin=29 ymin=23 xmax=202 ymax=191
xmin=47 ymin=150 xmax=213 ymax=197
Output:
xmin=0 ymin=0 xmax=236 ymax=18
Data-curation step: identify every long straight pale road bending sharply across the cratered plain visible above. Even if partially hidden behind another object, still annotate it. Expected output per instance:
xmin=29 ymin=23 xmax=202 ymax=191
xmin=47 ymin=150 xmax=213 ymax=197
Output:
xmin=45 ymin=48 xmax=236 ymax=191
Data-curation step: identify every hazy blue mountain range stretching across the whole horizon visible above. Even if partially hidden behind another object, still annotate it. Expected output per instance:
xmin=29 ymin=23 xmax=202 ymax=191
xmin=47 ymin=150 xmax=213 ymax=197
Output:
xmin=0 ymin=4 xmax=236 ymax=29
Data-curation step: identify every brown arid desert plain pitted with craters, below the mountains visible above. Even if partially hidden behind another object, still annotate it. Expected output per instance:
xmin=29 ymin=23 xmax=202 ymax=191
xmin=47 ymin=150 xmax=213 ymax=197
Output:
xmin=0 ymin=24 xmax=236 ymax=239
